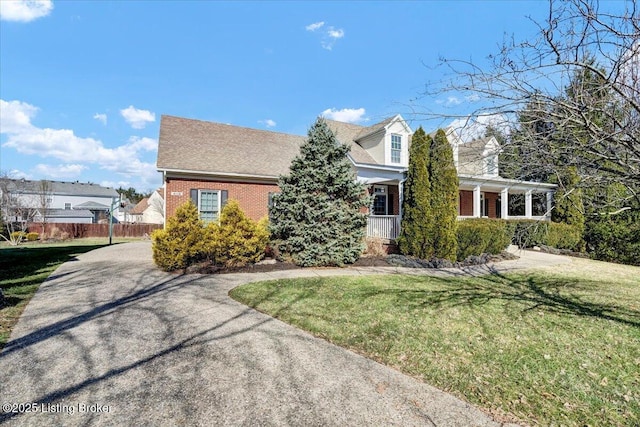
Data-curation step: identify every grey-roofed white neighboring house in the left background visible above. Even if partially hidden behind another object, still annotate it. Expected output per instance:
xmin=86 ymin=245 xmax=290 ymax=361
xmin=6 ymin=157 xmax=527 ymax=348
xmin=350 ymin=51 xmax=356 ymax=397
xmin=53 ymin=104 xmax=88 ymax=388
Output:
xmin=0 ymin=179 xmax=118 ymax=223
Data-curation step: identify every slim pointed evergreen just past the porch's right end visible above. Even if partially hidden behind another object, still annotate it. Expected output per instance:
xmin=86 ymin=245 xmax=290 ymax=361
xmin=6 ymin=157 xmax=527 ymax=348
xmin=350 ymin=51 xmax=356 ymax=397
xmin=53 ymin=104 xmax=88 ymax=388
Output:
xmin=551 ymin=166 xmax=585 ymax=249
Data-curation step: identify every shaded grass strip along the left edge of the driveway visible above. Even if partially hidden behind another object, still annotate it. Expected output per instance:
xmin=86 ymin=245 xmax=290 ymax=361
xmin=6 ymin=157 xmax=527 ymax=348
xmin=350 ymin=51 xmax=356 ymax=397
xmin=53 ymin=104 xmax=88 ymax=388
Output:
xmin=0 ymin=238 xmax=139 ymax=350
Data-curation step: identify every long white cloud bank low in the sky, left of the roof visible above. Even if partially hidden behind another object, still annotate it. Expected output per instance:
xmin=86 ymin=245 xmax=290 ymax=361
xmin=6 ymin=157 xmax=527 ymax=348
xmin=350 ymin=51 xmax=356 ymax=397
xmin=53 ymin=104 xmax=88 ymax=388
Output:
xmin=0 ymin=100 xmax=158 ymax=185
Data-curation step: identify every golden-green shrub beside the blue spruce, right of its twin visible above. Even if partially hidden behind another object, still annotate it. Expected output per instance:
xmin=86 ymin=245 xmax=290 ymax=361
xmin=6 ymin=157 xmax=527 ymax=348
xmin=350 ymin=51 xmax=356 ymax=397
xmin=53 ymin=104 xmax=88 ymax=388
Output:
xmin=206 ymin=200 xmax=269 ymax=267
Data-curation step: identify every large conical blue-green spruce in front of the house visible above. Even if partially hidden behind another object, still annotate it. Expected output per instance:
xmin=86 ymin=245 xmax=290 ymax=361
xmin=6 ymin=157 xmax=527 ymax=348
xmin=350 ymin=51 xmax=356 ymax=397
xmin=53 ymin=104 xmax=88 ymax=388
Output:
xmin=270 ymin=118 xmax=371 ymax=266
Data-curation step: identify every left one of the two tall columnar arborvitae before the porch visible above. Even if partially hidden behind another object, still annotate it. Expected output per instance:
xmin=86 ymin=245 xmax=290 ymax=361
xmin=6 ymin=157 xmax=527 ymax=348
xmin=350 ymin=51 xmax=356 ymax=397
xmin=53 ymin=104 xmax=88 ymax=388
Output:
xmin=397 ymin=127 xmax=434 ymax=259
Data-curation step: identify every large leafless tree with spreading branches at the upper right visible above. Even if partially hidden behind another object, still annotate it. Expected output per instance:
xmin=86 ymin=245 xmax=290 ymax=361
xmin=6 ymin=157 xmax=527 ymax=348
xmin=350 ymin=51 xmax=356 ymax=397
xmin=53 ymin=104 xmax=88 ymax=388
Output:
xmin=425 ymin=0 xmax=640 ymax=211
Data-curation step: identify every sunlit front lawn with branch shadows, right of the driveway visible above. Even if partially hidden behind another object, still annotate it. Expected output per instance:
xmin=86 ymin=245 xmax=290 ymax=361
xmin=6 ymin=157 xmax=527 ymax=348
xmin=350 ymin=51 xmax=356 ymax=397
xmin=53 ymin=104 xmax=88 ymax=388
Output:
xmin=231 ymin=260 xmax=640 ymax=426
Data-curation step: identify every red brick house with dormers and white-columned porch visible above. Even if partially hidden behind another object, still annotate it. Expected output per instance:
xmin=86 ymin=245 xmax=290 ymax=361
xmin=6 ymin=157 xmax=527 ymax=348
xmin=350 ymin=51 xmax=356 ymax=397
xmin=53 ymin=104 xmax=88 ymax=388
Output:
xmin=157 ymin=115 xmax=555 ymax=239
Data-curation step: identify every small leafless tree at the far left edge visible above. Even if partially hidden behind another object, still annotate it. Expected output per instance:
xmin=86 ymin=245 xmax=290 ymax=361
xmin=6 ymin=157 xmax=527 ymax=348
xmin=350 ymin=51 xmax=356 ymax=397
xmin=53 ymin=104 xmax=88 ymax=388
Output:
xmin=0 ymin=174 xmax=36 ymax=246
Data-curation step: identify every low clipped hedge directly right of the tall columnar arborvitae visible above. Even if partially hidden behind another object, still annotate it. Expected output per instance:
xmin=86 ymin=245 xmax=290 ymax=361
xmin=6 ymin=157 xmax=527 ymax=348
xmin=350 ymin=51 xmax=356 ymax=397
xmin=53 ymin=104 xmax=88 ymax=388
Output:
xmin=457 ymin=218 xmax=513 ymax=261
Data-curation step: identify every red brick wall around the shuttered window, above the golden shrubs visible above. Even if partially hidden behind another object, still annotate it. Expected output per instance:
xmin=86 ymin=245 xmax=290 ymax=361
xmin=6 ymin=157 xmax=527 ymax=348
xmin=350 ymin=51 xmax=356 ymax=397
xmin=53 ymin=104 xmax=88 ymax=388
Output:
xmin=167 ymin=178 xmax=280 ymax=220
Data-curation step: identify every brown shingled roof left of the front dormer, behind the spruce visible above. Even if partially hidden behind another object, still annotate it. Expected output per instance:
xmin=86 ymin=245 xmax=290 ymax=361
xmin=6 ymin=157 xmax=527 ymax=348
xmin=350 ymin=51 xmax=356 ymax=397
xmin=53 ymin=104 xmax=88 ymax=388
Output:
xmin=157 ymin=115 xmax=392 ymax=178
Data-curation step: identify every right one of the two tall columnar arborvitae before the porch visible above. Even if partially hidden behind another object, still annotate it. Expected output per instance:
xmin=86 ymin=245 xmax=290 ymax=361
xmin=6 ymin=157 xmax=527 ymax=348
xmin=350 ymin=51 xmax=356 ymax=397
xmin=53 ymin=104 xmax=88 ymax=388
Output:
xmin=428 ymin=129 xmax=458 ymax=261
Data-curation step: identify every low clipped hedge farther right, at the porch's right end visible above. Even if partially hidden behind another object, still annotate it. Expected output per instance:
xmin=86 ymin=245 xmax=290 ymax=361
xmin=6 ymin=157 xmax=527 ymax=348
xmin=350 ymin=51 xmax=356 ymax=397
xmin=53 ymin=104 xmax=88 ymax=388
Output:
xmin=509 ymin=219 xmax=584 ymax=252
